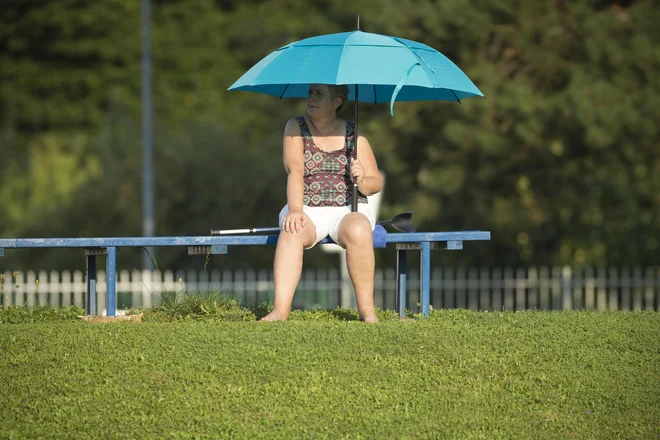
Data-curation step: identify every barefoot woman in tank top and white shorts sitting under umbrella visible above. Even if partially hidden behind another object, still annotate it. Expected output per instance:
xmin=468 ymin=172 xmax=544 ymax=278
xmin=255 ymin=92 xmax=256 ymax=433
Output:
xmin=262 ymin=84 xmax=383 ymax=322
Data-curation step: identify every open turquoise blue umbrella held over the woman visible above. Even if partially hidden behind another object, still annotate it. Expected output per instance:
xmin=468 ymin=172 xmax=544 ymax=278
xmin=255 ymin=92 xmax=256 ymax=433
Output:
xmin=229 ymin=30 xmax=484 ymax=210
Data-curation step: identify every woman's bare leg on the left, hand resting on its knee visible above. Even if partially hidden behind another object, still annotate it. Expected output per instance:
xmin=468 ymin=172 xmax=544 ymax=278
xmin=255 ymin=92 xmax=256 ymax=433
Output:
xmin=261 ymin=214 xmax=316 ymax=321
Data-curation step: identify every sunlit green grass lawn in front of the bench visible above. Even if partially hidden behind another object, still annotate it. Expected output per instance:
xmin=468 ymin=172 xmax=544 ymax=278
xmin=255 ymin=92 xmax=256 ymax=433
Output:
xmin=0 ymin=310 xmax=660 ymax=439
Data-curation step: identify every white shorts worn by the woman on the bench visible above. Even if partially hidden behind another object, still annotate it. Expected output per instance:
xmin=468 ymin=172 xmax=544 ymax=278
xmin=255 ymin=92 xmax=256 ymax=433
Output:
xmin=279 ymin=203 xmax=376 ymax=249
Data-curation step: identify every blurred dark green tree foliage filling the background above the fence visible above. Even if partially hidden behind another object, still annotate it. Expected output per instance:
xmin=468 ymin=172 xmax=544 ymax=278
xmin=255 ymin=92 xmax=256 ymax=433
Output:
xmin=0 ymin=0 xmax=660 ymax=269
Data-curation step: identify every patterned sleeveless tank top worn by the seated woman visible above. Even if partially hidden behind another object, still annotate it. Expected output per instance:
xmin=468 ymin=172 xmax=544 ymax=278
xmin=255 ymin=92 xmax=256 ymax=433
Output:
xmin=296 ymin=116 xmax=368 ymax=206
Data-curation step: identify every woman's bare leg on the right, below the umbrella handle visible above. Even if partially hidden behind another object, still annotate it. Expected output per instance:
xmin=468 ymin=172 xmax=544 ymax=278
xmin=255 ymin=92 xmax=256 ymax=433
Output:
xmin=339 ymin=212 xmax=378 ymax=322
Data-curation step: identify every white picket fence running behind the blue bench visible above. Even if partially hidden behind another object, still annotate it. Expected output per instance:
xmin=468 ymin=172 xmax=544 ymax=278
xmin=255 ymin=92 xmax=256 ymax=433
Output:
xmin=0 ymin=267 xmax=660 ymax=313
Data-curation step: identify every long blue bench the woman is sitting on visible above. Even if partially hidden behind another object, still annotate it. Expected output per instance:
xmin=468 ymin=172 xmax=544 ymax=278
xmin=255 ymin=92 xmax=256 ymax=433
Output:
xmin=0 ymin=229 xmax=490 ymax=318
